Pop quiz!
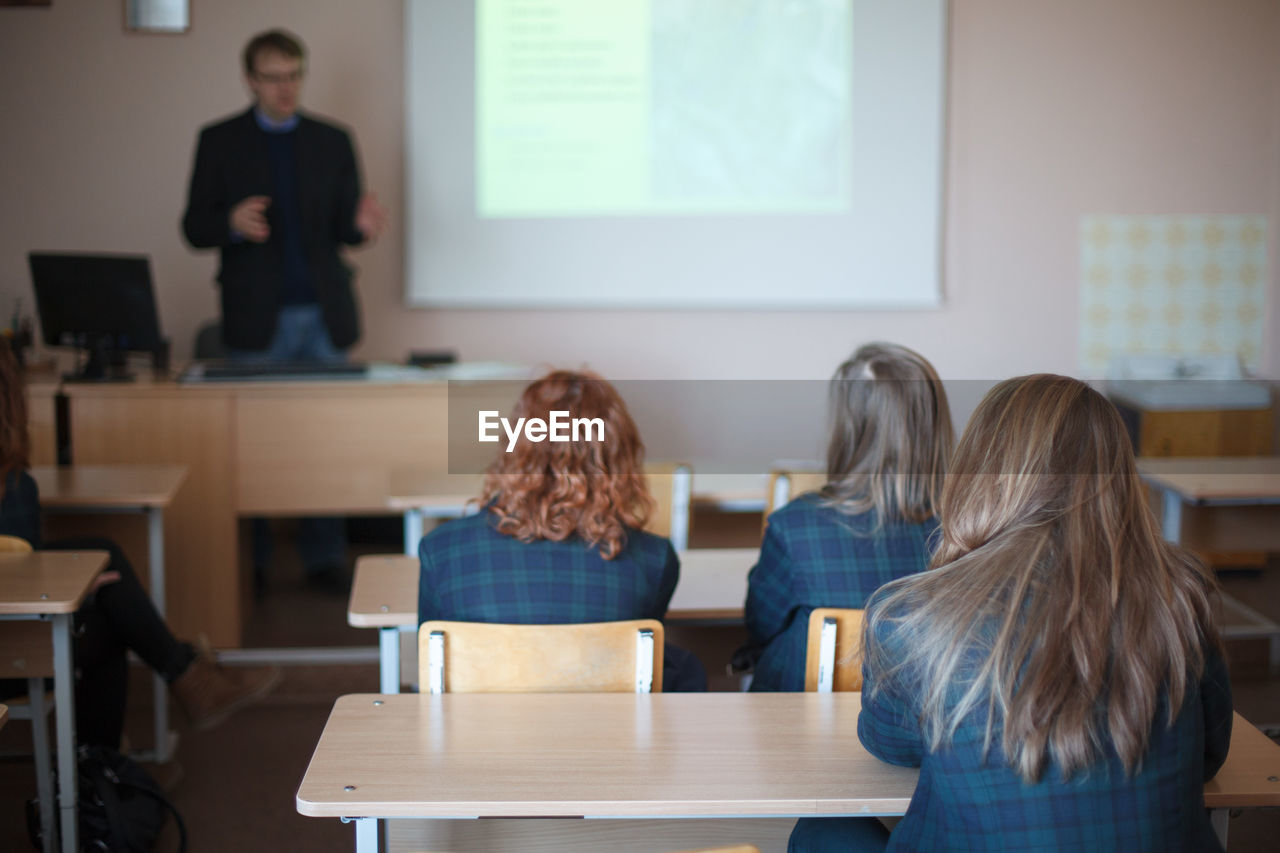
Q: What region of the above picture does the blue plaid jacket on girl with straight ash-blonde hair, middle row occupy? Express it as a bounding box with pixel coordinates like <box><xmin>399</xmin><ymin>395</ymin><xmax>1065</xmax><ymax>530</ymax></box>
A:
<box><xmin>745</xmin><ymin>494</ymin><xmax>938</xmax><ymax>690</ymax></box>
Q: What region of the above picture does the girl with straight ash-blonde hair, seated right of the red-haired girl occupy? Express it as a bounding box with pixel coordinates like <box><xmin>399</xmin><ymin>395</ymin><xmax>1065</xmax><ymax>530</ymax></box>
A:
<box><xmin>736</xmin><ymin>343</ymin><xmax>955</xmax><ymax>690</ymax></box>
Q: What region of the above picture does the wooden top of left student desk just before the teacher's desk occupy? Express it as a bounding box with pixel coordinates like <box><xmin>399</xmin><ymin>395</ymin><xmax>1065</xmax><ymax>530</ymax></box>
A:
<box><xmin>31</xmin><ymin>465</ymin><xmax>187</xmax><ymax>508</ymax></box>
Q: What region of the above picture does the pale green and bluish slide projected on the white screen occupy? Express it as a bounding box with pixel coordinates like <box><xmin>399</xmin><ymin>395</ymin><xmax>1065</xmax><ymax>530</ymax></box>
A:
<box><xmin>475</xmin><ymin>0</ymin><xmax>854</xmax><ymax>218</ymax></box>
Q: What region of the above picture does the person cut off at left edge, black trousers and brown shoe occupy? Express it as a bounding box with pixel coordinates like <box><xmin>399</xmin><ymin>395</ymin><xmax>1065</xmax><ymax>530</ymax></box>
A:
<box><xmin>0</xmin><ymin>342</ymin><xmax>280</xmax><ymax>749</ymax></box>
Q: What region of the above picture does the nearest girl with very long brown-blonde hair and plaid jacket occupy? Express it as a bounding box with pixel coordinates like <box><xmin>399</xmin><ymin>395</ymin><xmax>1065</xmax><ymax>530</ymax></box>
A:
<box><xmin>790</xmin><ymin>375</ymin><xmax>1231</xmax><ymax>852</ymax></box>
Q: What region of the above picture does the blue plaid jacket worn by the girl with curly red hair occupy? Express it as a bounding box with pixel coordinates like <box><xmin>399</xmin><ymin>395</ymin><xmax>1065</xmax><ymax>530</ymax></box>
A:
<box><xmin>417</xmin><ymin>512</ymin><xmax>680</xmax><ymax>625</ymax></box>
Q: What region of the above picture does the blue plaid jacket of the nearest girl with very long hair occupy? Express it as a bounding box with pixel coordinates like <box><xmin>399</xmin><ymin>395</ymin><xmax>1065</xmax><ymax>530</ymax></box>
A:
<box><xmin>858</xmin><ymin>594</ymin><xmax>1231</xmax><ymax>853</ymax></box>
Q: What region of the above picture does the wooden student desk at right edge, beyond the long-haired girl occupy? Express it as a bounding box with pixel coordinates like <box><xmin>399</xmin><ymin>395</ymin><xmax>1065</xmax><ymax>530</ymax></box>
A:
<box><xmin>1138</xmin><ymin>456</ymin><xmax>1280</xmax><ymax>672</ymax></box>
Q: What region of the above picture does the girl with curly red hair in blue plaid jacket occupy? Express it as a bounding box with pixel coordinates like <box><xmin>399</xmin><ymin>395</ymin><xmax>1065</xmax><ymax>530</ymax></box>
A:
<box><xmin>417</xmin><ymin>370</ymin><xmax>707</xmax><ymax>692</ymax></box>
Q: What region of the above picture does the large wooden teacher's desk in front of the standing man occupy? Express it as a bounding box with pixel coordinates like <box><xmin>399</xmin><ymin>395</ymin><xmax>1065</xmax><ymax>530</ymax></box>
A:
<box><xmin>29</xmin><ymin>365</ymin><xmax>524</xmax><ymax>648</ymax></box>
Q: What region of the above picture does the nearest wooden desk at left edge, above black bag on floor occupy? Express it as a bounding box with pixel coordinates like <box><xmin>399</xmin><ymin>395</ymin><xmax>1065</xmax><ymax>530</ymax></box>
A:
<box><xmin>0</xmin><ymin>551</ymin><xmax>108</xmax><ymax>853</ymax></box>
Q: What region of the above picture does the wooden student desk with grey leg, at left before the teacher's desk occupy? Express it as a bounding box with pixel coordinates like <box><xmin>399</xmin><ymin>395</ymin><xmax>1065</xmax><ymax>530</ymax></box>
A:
<box><xmin>31</xmin><ymin>465</ymin><xmax>187</xmax><ymax>765</ymax></box>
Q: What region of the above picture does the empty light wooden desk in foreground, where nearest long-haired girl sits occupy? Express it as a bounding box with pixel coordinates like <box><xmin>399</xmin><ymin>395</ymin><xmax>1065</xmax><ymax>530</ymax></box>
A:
<box><xmin>297</xmin><ymin>693</ymin><xmax>1280</xmax><ymax>853</ymax></box>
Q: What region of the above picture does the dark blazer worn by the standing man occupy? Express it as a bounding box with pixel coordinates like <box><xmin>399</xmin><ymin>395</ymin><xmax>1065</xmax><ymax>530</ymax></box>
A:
<box><xmin>182</xmin><ymin>109</ymin><xmax>364</xmax><ymax>350</ymax></box>
